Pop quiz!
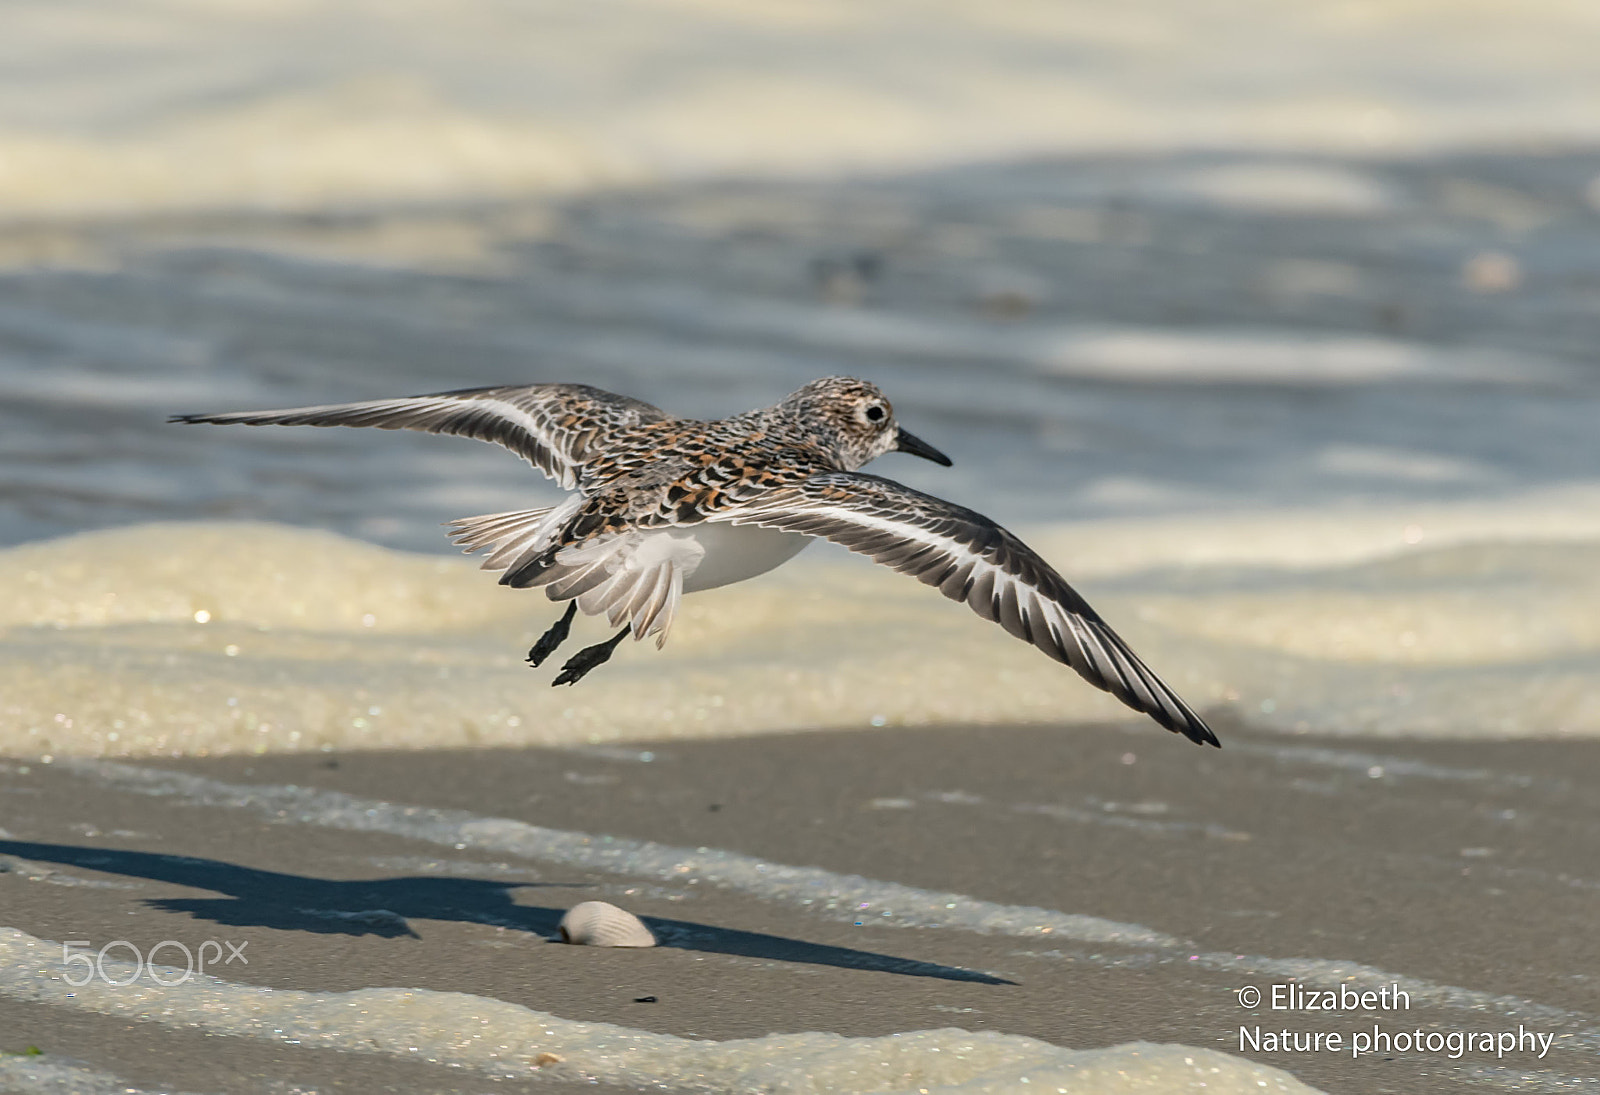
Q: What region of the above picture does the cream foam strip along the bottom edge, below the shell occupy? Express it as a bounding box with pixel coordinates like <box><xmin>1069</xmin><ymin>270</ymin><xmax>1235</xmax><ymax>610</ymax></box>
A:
<box><xmin>0</xmin><ymin>929</ymin><xmax>1312</xmax><ymax>1095</ymax></box>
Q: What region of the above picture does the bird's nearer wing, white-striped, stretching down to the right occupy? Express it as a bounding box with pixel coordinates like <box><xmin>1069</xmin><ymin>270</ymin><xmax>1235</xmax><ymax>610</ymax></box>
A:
<box><xmin>717</xmin><ymin>472</ymin><xmax>1219</xmax><ymax>744</ymax></box>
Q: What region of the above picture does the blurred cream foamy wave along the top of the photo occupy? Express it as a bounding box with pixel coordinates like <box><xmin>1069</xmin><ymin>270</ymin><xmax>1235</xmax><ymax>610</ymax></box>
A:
<box><xmin>9</xmin><ymin>0</ymin><xmax>1600</xmax><ymax>219</ymax></box>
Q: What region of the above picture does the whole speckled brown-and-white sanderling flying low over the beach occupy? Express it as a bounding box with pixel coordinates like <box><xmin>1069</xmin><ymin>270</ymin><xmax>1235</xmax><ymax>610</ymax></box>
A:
<box><xmin>171</xmin><ymin>376</ymin><xmax>1219</xmax><ymax>744</ymax></box>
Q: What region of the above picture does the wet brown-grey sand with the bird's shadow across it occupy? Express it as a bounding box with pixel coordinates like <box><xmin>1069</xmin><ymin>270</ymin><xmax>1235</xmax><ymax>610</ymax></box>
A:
<box><xmin>0</xmin><ymin>725</ymin><xmax>1600</xmax><ymax>1092</ymax></box>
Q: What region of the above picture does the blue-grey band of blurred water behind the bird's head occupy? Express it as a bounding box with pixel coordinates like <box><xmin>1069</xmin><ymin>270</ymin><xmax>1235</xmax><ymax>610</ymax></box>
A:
<box><xmin>0</xmin><ymin>154</ymin><xmax>1600</xmax><ymax>551</ymax></box>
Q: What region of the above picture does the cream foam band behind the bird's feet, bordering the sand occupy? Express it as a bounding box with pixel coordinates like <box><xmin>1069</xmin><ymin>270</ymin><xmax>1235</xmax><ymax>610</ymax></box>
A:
<box><xmin>0</xmin><ymin>488</ymin><xmax>1600</xmax><ymax>756</ymax></box>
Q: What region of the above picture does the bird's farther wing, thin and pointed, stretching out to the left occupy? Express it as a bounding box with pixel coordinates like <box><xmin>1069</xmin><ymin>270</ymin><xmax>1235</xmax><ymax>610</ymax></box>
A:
<box><xmin>168</xmin><ymin>384</ymin><xmax>667</xmax><ymax>490</ymax></box>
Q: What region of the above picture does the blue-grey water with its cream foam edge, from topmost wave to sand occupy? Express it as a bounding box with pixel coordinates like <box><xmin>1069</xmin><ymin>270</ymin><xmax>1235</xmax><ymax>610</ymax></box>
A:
<box><xmin>9</xmin><ymin>154</ymin><xmax>1600</xmax><ymax>756</ymax></box>
